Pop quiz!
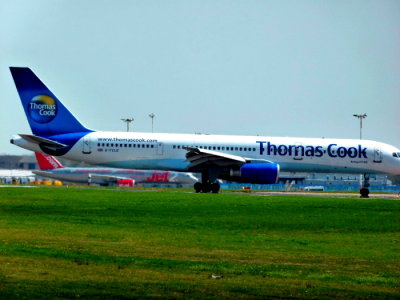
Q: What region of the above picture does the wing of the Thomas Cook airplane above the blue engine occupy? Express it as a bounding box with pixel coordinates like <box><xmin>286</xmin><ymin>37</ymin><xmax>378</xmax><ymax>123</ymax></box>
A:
<box><xmin>184</xmin><ymin>147</ymin><xmax>270</xmax><ymax>170</ymax></box>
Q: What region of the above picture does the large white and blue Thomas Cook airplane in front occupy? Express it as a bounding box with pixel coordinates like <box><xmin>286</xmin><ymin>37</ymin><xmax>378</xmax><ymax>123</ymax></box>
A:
<box><xmin>10</xmin><ymin>67</ymin><xmax>400</xmax><ymax>197</ymax></box>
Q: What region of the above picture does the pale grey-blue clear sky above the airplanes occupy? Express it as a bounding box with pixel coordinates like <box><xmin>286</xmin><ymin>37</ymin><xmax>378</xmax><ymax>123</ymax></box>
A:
<box><xmin>0</xmin><ymin>0</ymin><xmax>400</xmax><ymax>154</ymax></box>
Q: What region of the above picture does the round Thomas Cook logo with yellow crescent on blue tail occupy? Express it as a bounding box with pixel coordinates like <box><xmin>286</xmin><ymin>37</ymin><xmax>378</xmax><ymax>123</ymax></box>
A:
<box><xmin>28</xmin><ymin>95</ymin><xmax>57</xmax><ymax>123</ymax></box>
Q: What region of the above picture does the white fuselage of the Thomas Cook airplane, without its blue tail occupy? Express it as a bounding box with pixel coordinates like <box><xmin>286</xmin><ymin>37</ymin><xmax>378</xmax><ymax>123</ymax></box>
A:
<box><xmin>14</xmin><ymin>131</ymin><xmax>400</xmax><ymax>175</ymax></box>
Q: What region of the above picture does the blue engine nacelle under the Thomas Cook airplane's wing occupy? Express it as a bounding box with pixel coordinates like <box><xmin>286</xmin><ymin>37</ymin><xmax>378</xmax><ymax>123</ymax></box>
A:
<box><xmin>230</xmin><ymin>163</ymin><xmax>279</xmax><ymax>184</ymax></box>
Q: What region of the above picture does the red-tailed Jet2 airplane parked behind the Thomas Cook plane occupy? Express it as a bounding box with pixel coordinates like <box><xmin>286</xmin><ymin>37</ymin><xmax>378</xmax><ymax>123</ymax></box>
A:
<box><xmin>32</xmin><ymin>152</ymin><xmax>198</xmax><ymax>186</ymax></box>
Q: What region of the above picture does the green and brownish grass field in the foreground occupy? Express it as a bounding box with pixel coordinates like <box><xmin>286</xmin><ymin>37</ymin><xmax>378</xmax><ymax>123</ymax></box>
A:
<box><xmin>0</xmin><ymin>187</ymin><xmax>400</xmax><ymax>299</ymax></box>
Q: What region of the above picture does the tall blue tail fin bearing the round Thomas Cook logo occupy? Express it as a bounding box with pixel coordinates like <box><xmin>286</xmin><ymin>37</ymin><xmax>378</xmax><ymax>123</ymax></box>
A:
<box><xmin>10</xmin><ymin>67</ymin><xmax>92</xmax><ymax>135</ymax></box>
